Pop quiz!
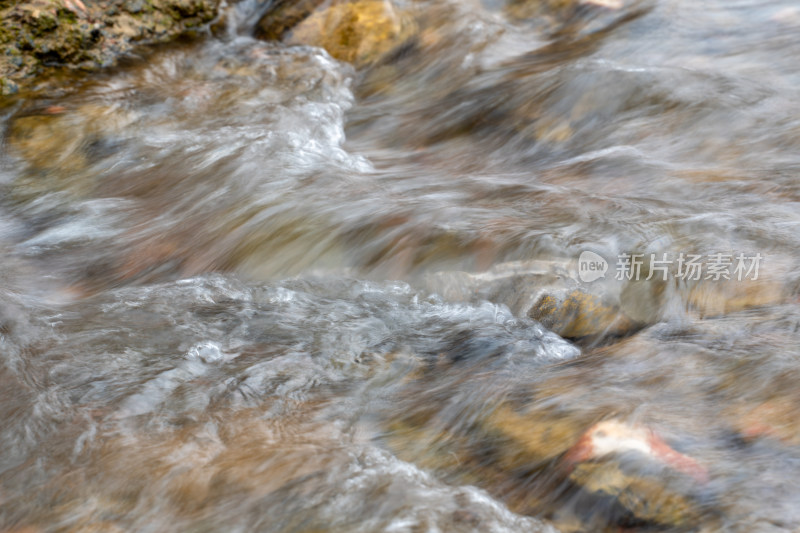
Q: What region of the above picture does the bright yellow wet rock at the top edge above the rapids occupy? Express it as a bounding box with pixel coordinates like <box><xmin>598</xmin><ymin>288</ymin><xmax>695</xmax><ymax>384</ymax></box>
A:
<box><xmin>287</xmin><ymin>0</ymin><xmax>416</xmax><ymax>67</ymax></box>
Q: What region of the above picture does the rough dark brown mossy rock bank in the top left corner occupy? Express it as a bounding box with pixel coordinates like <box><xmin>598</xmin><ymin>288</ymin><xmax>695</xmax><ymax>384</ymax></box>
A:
<box><xmin>0</xmin><ymin>0</ymin><xmax>219</xmax><ymax>95</ymax></box>
